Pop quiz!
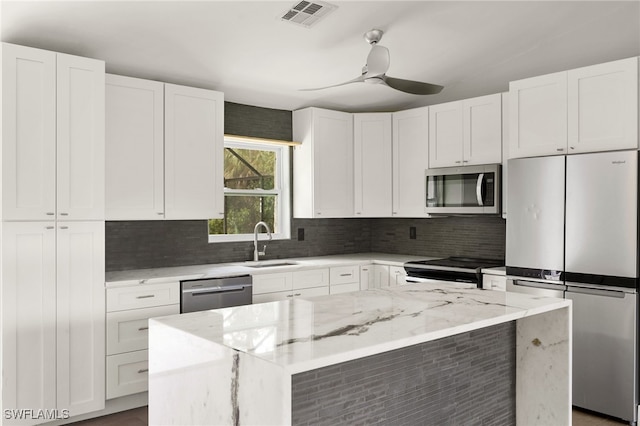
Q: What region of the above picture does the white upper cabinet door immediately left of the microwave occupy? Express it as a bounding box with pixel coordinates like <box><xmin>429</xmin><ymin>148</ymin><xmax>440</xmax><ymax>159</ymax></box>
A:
<box><xmin>391</xmin><ymin>107</ymin><xmax>429</xmax><ymax>217</ymax></box>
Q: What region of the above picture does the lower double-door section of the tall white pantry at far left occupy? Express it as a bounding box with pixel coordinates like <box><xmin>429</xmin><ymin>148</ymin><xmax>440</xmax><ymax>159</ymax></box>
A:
<box><xmin>1</xmin><ymin>221</ymin><xmax>105</xmax><ymax>424</ymax></box>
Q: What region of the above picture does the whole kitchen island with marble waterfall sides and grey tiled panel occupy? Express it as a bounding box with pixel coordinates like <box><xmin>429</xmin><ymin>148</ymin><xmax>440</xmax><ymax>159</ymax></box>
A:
<box><xmin>149</xmin><ymin>284</ymin><xmax>571</xmax><ymax>425</ymax></box>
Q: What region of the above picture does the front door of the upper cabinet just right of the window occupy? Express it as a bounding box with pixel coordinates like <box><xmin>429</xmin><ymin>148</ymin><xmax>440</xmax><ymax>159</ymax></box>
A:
<box><xmin>313</xmin><ymin>110</ymin><xmax>353</xmax><ymax>217</ymax></box>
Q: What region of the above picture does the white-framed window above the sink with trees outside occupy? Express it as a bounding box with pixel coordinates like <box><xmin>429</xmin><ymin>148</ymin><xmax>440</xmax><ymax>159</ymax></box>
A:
<box><xmin>209</xmin><ymin>140</ymin><xmax>291</xmax><ymax>242</ymax></box>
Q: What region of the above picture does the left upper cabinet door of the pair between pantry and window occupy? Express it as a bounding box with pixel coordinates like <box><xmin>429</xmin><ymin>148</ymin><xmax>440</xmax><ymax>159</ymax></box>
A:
<box><xmin>105</xmin><ymin>74</ymin><xmax>164</xmax><ymax>220</ymax></box>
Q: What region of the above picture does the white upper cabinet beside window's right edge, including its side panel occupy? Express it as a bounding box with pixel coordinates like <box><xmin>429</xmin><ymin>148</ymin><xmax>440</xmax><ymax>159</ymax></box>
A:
<box><xmin>293</xmin><ymin>108</ymin><xmax>354</xmax><ymax>218</ymax></box>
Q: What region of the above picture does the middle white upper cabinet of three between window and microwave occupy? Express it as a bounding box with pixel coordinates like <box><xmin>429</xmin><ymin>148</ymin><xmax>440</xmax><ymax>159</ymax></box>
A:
<box><xmin>353</xmin><ymin>113</ymin><xmax>392</xmax><ymax>217</ymax></box>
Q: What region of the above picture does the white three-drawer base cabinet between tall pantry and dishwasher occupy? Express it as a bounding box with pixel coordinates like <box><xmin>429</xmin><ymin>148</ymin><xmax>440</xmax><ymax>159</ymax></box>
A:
<box><xmin>106</xmin><ymin>281</ymin><xmax>180</xmax><ymax>399</ymax></box>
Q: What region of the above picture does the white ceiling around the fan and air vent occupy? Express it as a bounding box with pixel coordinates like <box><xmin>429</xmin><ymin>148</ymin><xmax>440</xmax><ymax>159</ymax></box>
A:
<box><xmin>0</xmin><ymin>0</ymin><xmax>640</xmax><ymax>111</ymax></box>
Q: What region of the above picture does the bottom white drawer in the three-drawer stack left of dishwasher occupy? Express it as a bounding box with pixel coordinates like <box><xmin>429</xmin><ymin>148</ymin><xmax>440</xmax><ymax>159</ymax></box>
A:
<box><xmin>107</xmin><ymin>351</ymin><xmax>149</xmax><ymax>399</ymax></box>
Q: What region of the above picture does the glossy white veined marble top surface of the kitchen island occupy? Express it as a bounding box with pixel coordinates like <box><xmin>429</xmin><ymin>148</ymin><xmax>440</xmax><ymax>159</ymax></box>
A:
<box><xmin>150</xmin><ymin>284</ymin><xmax>571</xmax><ymax>374</ymax></box>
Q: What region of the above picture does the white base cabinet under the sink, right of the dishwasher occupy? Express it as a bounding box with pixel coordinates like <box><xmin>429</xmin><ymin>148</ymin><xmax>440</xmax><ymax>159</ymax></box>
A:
<box><xmin>252</xmin><ymin>268</ymin><xmax>329</xmax><ymax>303</ymax></box>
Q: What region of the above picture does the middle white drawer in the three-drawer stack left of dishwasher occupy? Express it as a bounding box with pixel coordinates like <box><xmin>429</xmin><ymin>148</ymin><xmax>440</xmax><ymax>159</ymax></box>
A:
<box><xmin>107</xmin><ymin>304</ymin><xmax>180</xmax><ymax>355</ymax></box>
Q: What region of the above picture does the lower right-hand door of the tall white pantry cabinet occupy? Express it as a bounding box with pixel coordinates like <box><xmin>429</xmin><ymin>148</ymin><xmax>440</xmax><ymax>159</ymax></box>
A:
<box><xmin>56</xmin><ymin>222</ymin><xmax>106</xmax><ymax>416</ymax></box>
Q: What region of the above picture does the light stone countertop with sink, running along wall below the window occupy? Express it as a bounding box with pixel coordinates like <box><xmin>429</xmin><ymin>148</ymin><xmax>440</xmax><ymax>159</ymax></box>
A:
<box><xmin>105</xmin><ymin>253</ymin><xmax>437</xmax><ymax>287</ymax></box>
